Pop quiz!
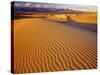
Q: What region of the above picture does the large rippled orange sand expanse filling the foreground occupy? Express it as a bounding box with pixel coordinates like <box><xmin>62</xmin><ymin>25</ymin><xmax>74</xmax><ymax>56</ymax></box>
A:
<box><xmin>14</xmin><ymin>18</ymin><xmax>97</xmax><ymax>73</ymax></box>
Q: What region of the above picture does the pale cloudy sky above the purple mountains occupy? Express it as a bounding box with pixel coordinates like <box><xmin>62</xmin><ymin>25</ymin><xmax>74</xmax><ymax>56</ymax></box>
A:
<box><xmin>14</xmin><ymin>1</ymin><xmax>97</xmax><ymax>12</ymax></box>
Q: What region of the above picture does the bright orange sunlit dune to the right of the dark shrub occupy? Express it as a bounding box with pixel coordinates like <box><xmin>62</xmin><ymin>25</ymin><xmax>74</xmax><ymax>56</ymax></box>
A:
<box><xmin>71</xmin><ymin>13</ymin><xmax>97</xmax><ymax>24</ymax></box>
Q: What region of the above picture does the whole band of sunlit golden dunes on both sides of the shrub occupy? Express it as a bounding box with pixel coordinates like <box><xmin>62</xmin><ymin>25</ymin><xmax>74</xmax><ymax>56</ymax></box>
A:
<box><xmin>47</xmin><ymin>13</ymin><xmax>97</xmax><ymax>24</ymax></box>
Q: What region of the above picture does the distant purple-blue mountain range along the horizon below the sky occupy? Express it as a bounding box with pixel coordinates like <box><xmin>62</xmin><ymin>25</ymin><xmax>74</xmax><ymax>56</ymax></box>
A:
<box><xmin>14</xmin><ymin>7</ymin><xmax>92</xmax><ymax>14</ymax></box>
